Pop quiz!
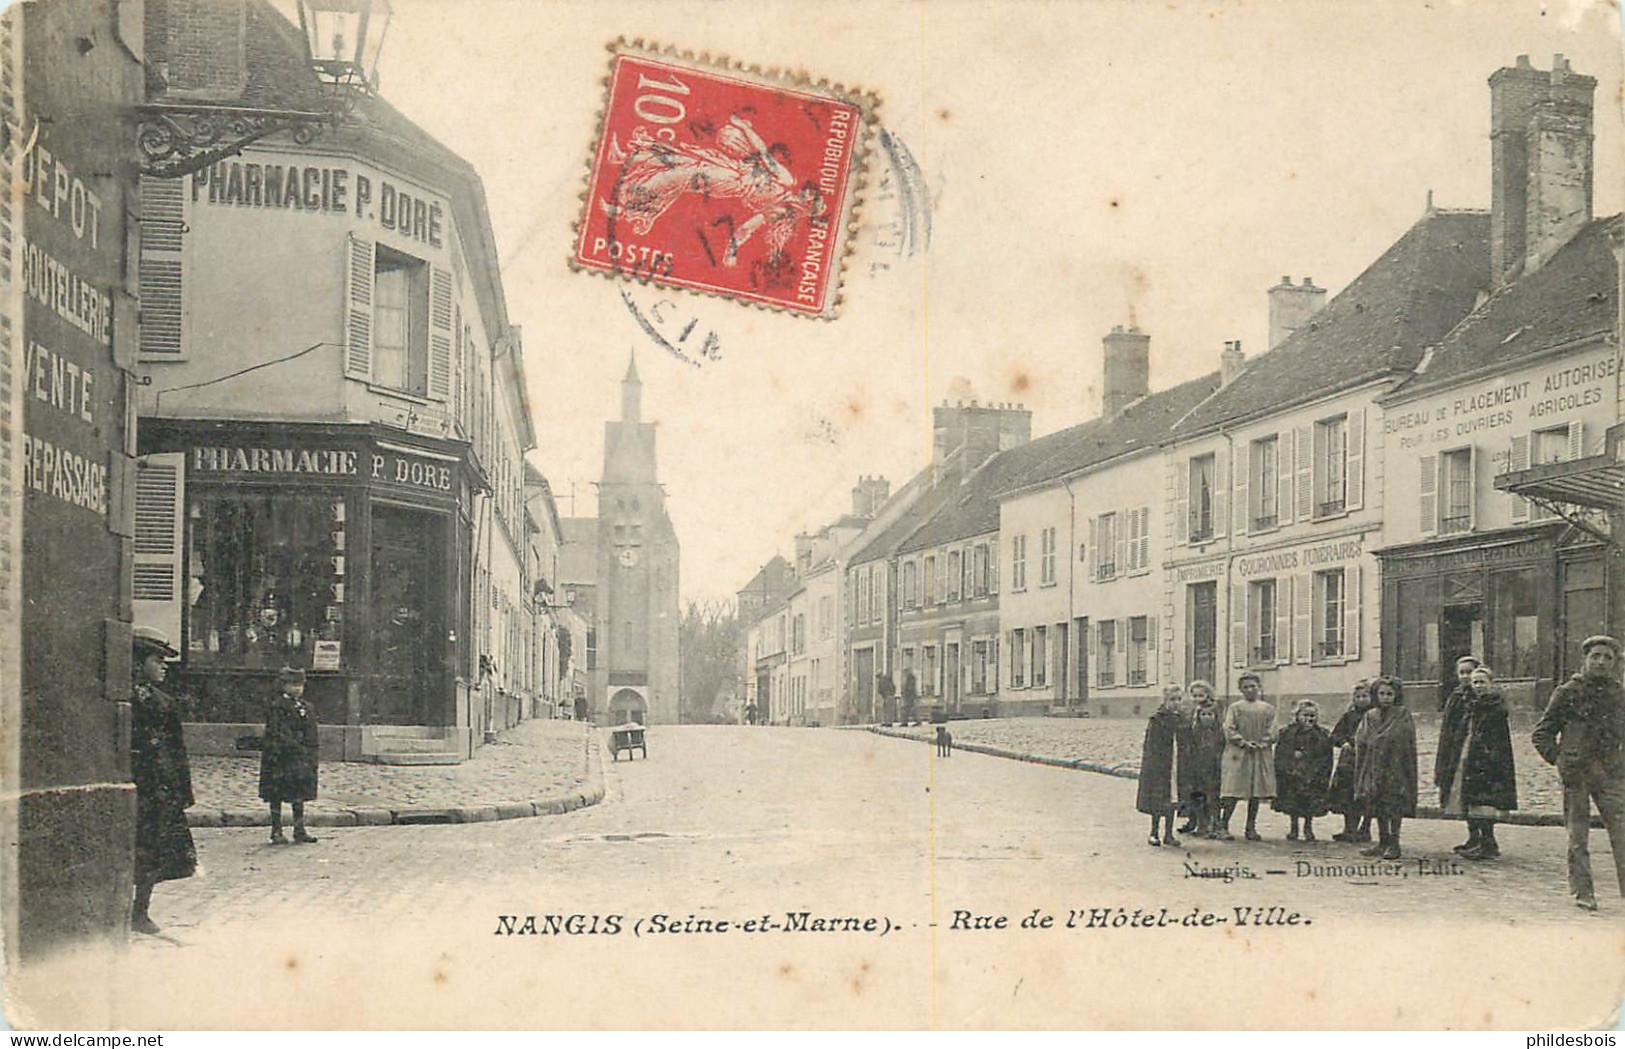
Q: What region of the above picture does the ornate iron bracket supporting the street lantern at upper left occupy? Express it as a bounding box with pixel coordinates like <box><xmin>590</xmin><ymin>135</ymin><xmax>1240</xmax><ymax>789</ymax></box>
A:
<box><xmin>135</xmin><ymin>104</ymin><xmax>340</xmax><ymax>179</ymax></box>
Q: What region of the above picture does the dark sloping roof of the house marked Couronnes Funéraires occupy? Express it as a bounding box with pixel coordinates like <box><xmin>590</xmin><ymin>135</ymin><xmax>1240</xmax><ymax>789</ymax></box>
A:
<box><xmin>1173</xmin><ymin>209</ymin><xmax>1490</xmax><ymax>438</ymax></box>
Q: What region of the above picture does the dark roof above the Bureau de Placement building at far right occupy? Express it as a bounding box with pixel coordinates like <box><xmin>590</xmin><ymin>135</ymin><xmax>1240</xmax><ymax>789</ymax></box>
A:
<box><xmin>1399</xmin><ymin>214</ymin><xmax>1625</xmax><ymax>396</ymax></box>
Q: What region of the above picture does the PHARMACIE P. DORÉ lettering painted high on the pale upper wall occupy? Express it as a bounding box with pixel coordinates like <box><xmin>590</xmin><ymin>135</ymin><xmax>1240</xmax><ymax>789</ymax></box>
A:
<box><xmin>192</xmin><ymin>158</ymin><xmax>445</xmax><ymax>248</ymax></box>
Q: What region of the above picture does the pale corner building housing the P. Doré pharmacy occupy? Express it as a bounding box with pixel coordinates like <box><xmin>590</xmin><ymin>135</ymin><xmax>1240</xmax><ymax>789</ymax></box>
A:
<box><xmin>133</xmin><ymin>0</ymin><xmax>535</xmax><ymax>760</ymax></box>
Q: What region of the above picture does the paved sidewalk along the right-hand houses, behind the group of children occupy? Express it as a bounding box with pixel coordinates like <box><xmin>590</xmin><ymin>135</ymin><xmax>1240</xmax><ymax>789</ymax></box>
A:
<box><xmin>869</xmin><ymin>718</ymin><xmax>1563</xmax><ymax>825</ymax></box>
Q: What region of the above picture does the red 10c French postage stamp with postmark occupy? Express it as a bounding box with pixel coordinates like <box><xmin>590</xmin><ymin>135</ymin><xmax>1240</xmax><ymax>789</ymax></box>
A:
<box><xmin>572</xmin><ymin>50</ymin><xmax>869</xmax><ymax>317</ymax></box>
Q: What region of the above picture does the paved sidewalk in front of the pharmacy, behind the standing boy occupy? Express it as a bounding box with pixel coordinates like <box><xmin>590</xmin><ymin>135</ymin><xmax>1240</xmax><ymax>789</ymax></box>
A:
<box><xmin>187</xmin><ymin>721</ymin><xmax>605</xmax><ymax>827</ymax></box>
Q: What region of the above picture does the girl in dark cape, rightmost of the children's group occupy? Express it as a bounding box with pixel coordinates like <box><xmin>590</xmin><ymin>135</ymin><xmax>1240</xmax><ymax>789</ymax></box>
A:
<box><xmin>1433</xmin><ymin>664</ymin><xmax>1518</xmax><ymax>859</ymax></box>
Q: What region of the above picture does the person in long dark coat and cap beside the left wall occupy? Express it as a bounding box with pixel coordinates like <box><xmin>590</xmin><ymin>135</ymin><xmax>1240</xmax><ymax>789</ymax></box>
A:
<box><xmin>130</xmin><ymin>627</ymin><xmax>198</xmax><ymax>935</ymax></box>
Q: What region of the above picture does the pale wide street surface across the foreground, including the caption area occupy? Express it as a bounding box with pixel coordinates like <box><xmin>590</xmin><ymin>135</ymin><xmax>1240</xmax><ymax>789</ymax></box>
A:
<box><xmin>15</xmin><ymin>727</ymin><xmax>1625</xmax><ymax>1028</ymax></box>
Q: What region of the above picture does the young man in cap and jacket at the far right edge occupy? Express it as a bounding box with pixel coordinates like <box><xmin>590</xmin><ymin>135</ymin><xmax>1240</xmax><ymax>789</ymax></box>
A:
<box><xmin>1534</xmin><ymin>635</ymin><xmax>1625</xmax><ymax>911</ymax></box>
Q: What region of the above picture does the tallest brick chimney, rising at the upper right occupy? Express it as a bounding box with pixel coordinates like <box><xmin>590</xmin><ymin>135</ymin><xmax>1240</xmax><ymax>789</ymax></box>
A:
<box><xmin>1490</xmin><ymin>55</ymin><xmax>1597</xmax><ymax>287</ymax></box>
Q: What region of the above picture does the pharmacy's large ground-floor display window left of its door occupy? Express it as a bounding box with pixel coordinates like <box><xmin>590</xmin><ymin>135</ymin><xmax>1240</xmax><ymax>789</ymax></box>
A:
<box><xmin>187</xmin><ymin>492</ymin><xmax>346</xmax><ymax>667</ymax></box>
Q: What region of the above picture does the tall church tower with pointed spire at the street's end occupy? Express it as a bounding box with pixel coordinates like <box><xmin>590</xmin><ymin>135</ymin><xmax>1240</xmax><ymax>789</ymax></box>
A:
<box><xmin>593</xmin><ymin>359</ymin><xmax>679</xmax><ymax>724</ymax></box>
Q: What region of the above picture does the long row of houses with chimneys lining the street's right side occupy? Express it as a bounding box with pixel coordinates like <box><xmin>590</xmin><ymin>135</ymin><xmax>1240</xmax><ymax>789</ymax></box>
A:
<box><xmin>739</xmin><ymin>55</ymin><xmax>1625</xmax><ymax>724</ymax></box>
